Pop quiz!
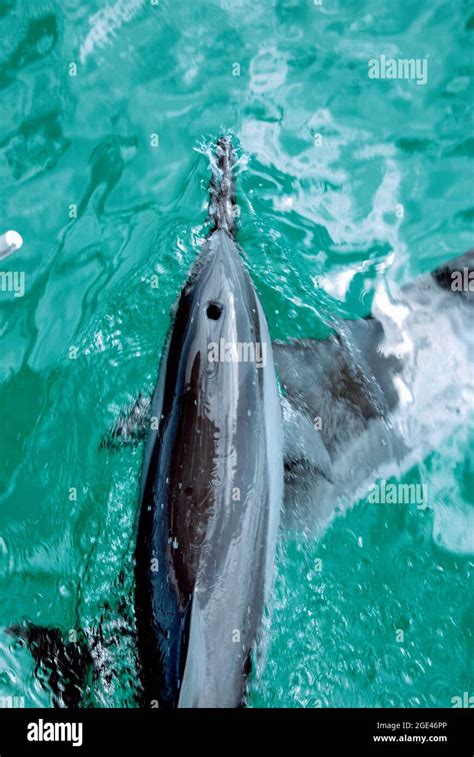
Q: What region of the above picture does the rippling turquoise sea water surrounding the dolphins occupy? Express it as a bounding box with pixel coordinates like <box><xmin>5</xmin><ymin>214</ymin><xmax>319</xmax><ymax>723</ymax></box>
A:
<box><xmin>0</xmin><ymin>0</ymin><xmax>474</xmax><ymax>707</ymax></box>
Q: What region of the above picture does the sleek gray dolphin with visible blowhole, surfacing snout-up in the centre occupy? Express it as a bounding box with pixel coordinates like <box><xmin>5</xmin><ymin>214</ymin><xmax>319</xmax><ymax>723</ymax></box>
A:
<box><xmin>135</xmin><ymin>138</ymin><xmax>283</xmax><ymax>708</ymax></box>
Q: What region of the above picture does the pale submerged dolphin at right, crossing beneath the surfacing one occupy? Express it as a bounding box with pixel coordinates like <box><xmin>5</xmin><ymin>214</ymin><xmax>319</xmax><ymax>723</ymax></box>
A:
<box><xmin>273</xmin><ymin>250</ymin><xmax>474</xmax><ymax>535</ymax></box>
